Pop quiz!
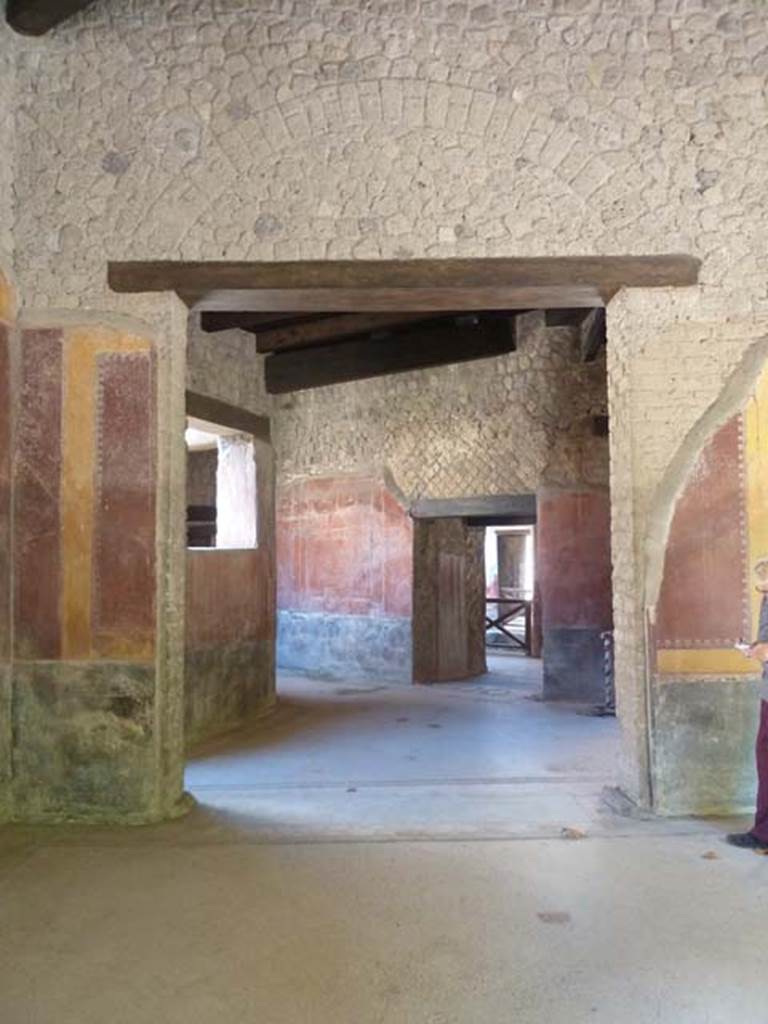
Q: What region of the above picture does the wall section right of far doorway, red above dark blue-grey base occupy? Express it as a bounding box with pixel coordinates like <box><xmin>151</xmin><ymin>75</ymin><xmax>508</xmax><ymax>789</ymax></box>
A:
<box><xmin>537</xmin><ymin>490</ymin><xmax>612</xmax><ymax>703</ymax></box>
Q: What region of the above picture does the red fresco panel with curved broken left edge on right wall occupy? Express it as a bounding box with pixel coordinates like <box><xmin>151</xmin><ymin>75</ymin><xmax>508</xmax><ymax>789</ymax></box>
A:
<box><xmin>656</xmin><ymin>416</ymin><xmax>750</xmax><ymax>647</ymax></box>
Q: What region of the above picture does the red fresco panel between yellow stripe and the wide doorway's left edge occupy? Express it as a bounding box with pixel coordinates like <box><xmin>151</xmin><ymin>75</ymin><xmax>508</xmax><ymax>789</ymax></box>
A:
<box><xmin>93</xmin><ymin>352</ymin><xmax>155</xmax><ymax>640</ymax></box>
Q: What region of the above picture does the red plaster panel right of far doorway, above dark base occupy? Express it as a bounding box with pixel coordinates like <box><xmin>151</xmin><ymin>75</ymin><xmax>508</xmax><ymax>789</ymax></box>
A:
<box><xmin>537</xmin><ymin>492</ymin><xmax>612</xmax><ymax>629</ymax></box>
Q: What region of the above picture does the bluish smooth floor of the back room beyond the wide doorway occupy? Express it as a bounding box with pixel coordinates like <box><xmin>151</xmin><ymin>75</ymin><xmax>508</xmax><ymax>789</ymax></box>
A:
<box><xmin>186</xmin><ymin>654</ymin><xmax>618</xmax><ymax>839</ymax></box>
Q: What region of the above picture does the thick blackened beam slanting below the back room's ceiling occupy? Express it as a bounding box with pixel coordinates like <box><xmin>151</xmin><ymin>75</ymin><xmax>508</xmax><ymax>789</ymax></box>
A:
<box><xmin>264</xmin><ymin>316</ymin><xmax>516</xmax><ymax>394</ymax></box>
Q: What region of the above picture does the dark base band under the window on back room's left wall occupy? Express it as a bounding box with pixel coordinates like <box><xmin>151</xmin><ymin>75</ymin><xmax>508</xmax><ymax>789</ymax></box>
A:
<box><xmin>184</xmin><ymin>640</ymin><xmax>274</xmax><ymax>746</ymax></box>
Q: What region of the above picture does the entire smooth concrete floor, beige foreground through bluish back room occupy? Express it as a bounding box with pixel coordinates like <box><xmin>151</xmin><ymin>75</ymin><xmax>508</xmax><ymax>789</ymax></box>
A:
<box><xmin>0</xmin><ymin>663</ymin><xmax>768</xmax><ymax>1024</ymax></box>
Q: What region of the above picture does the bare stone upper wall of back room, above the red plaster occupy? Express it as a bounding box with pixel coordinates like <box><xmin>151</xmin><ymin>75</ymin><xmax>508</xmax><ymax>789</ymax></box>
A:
<box><xmin>275</xmin><ymin>313</ymin><xmax>608</xmax><ymax>505</ymax></box>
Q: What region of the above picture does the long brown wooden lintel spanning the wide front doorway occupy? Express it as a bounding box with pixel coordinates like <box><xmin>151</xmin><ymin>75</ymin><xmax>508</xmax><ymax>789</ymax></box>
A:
<box><xmin>109</xmin><ymin>255</ymin><xmax>699</xmax><ymax>312</ymax></box>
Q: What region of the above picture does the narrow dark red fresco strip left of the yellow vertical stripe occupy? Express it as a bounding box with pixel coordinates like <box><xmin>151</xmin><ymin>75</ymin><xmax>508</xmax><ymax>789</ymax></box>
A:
<box><xmin>13</xmin><ymin>330</ymin><xmax>62</xmax><ymax>659</ymax></box>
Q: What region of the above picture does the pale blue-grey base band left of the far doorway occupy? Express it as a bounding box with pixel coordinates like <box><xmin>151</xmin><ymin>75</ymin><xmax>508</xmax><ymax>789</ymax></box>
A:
<box><xmin>278</xmin><ymin>610</ymin><xmax>412</xmax><ymax>683</ymax></box>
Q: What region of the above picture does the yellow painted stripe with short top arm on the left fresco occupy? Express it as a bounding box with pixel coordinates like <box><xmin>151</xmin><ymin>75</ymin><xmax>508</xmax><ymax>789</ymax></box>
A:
<box><xmin>61</xmin><ymin>328</ymin><xmax>150</xmax><ymax>659</ymax></box>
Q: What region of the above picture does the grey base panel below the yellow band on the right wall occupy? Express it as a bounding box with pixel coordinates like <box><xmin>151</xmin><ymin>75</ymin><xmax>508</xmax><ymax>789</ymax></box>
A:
<box><xmin>653</xmin><ymin>678</ymin><xmax>760</xmax><ymax>815</ymax></box>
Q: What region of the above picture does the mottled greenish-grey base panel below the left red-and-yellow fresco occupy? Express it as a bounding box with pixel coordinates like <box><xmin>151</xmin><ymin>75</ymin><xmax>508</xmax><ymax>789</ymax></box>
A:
<box><xmin>13</xmin><ymin>662</ymin><xmax>156</xmax><ymax>821</ymax></box>
